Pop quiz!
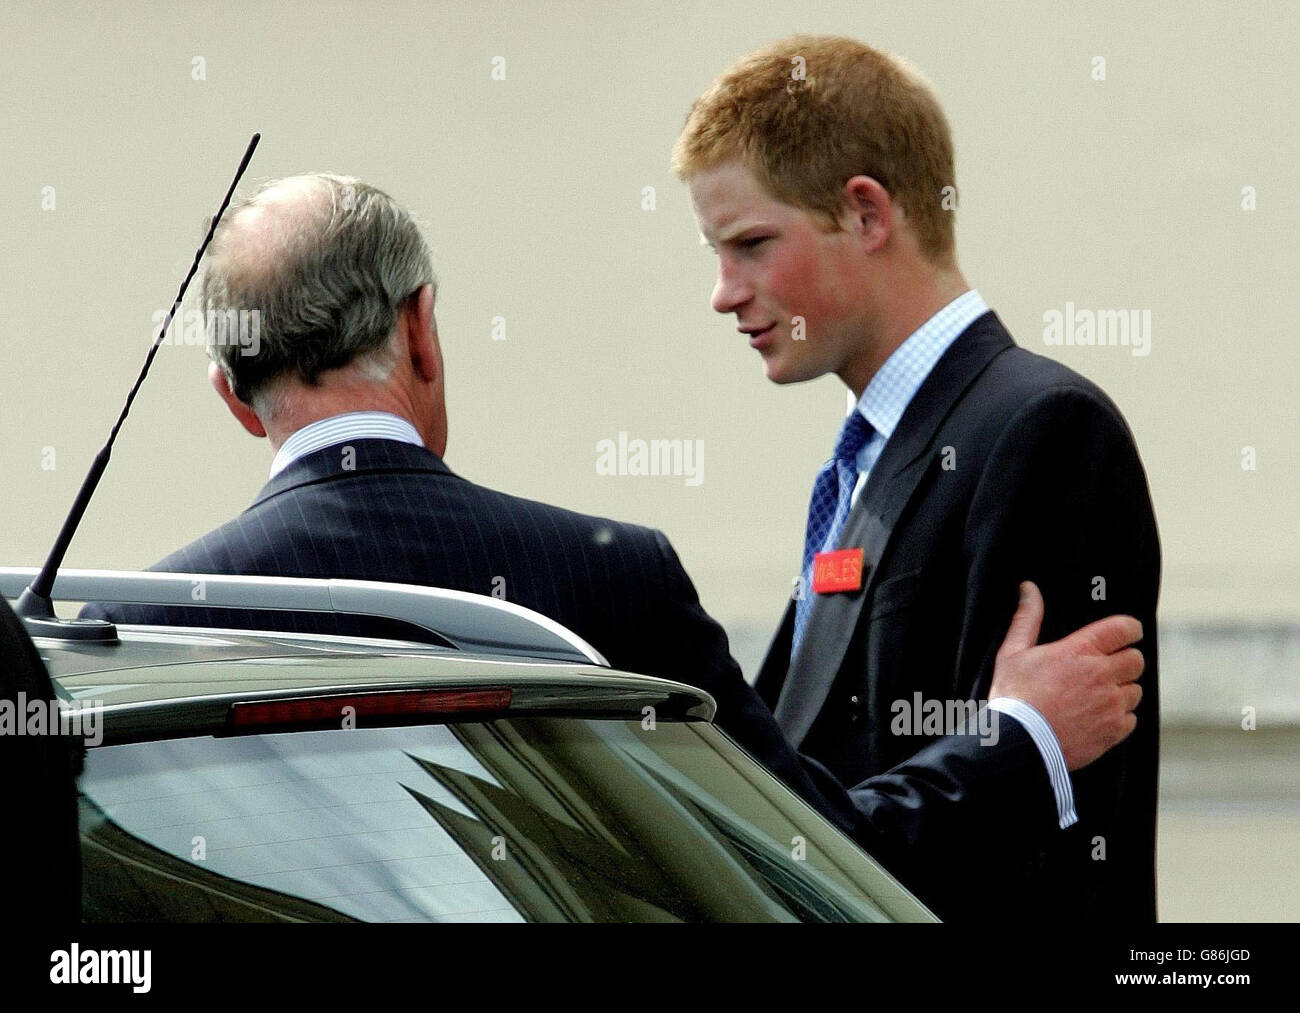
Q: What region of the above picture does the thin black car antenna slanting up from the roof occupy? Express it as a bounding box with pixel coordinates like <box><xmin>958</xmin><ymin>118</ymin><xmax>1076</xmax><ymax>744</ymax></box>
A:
<box><xmin>14</xmin><ymin>134</ymin><xmax>261</xmax><ymax>640</ymax></box>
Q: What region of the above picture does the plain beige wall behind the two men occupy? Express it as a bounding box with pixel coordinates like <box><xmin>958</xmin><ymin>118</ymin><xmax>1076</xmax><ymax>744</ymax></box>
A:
<box><xmin>0</xmin><ymin>0</ymin><xmax>1300</xmax><ymax>625</ymax></box>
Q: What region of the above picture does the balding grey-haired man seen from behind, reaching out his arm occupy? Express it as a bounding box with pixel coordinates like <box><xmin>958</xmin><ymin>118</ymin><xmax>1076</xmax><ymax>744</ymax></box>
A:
<box><xmin>86</xmin><ymin>174</ymin><xmax>1141</xmax><ymax>894</ymax></box>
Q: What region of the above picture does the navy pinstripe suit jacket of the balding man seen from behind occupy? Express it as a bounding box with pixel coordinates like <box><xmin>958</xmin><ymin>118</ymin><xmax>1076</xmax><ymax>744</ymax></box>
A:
<box><xmin>82</xmin><ymin>440</ymin><xmax>1057</xmax><ymax>899</ymax></box>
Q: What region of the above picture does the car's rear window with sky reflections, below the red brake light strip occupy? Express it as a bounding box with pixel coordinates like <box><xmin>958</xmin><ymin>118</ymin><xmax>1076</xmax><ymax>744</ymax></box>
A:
<box><xmin>81</xmin><ymin>717</ymin><xmax>928</xmax><ymax>922</ymax></box>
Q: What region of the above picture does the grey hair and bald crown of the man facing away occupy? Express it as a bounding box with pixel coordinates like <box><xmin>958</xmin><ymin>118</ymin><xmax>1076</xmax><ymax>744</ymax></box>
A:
<box><xmin>200</xmin><ymin>173</ymin><xmax>437</xmax><ymax>415</ymax></box>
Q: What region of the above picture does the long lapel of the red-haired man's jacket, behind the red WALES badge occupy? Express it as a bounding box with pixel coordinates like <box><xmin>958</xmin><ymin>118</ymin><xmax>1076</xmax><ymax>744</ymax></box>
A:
<box><xmin>764</xmin><ymin>312</ymin><xmax>1014</xmax><ymax>746</ymax></box>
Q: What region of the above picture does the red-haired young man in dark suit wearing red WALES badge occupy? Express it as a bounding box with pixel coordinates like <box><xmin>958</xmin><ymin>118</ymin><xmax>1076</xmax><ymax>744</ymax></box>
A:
<box><xmin>673</xmin><ymin>36</ymin><xmax>1160</xmax><ymax>921</ymax></box>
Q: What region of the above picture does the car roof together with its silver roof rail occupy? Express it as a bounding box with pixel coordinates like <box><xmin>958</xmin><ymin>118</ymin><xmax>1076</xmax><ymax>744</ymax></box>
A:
<box><xmin>0</xmin><ymin>567</ymin><xmax>715</xmax><ymax>741</ymax></box>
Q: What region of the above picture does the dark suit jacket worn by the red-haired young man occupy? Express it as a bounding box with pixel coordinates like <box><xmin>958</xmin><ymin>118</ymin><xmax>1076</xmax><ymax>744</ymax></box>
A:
<box><xmin>755</xmin><ymin>312</ymin><xmax>1160</xmax><ymax>922</ymax></box>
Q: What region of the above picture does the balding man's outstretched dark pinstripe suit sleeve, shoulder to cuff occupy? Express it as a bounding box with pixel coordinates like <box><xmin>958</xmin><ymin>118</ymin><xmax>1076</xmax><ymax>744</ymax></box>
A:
<box><xmin>641</xmin><ymin>532</ymin><xmax>1057</xmax><ymax>883</ymax></box>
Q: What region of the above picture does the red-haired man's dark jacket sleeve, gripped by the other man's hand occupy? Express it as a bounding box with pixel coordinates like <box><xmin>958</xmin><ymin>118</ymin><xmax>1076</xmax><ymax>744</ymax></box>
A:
<box><xmin>957</xmin><ymin>388</ymin><xmax>1160</xmax><ymax>921</ymax></box>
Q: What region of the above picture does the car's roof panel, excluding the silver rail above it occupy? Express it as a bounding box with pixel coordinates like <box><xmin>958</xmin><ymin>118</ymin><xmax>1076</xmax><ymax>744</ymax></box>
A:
<box><xmin>34</xmin><ymin>624</ymin><xmax>715</xmax><ymax>743</ymax></box>
